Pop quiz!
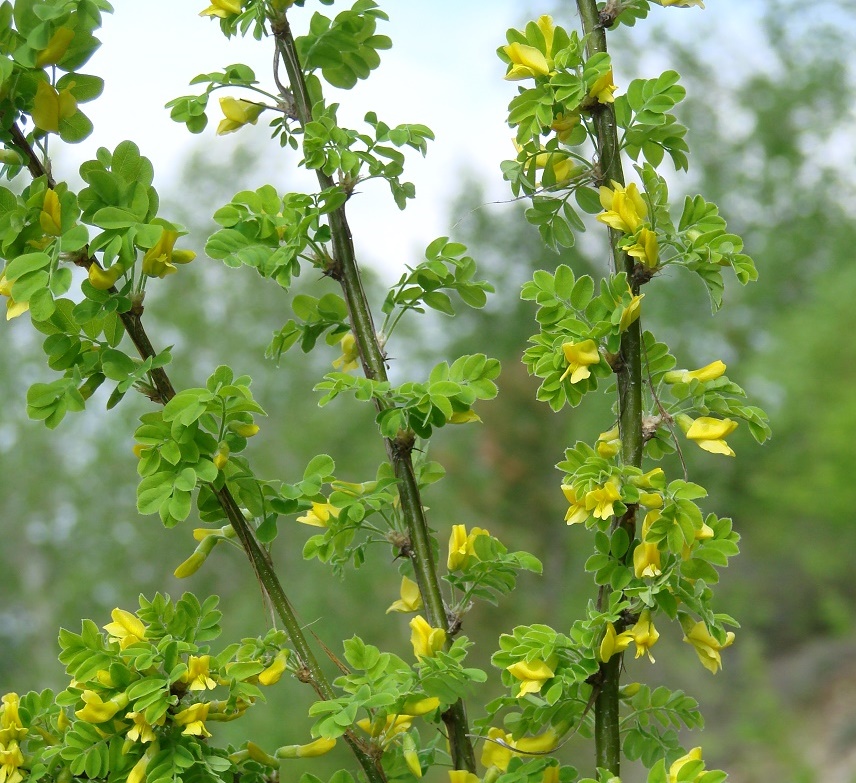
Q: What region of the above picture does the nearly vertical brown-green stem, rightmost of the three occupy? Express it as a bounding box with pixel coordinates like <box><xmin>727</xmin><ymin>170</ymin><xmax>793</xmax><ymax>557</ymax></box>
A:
<box><xmin>577</xmin><ymin>0</ymin><xmax>643</xmax><ymax>775</ymax></box>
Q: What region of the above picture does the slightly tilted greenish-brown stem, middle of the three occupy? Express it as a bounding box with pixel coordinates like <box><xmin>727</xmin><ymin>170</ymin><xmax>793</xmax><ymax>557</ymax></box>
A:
<box><xmin>272</xmin><ymin>13</ymin><xmax>476</xmax><ymax>772</ymax></box>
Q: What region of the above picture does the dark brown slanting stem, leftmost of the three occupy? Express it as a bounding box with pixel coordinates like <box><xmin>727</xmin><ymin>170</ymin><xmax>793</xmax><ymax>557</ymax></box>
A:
<box><xmin>3</xmin><ymin>118</ymin><xmax>386</xmax><ymax>783</ymax></box>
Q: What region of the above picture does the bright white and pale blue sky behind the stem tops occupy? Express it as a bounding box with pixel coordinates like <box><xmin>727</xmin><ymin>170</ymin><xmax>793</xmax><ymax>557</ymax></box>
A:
<box><xmin>55</xmin><ymin>0</ymin><xmax>755</xmax><ymax>282</ymax></box>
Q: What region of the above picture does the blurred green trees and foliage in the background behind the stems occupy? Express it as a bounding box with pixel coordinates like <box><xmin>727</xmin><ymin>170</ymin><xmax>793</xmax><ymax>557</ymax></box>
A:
<box><xmin>0</xmin><ymin>2</ymin><xmax>856</xmax><ymax>783</ymax></box>
